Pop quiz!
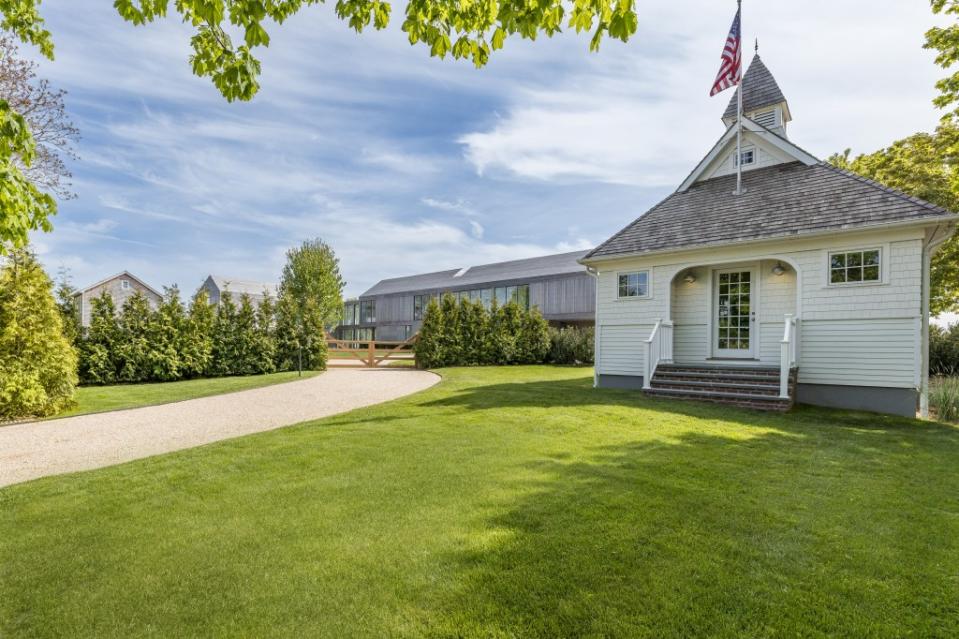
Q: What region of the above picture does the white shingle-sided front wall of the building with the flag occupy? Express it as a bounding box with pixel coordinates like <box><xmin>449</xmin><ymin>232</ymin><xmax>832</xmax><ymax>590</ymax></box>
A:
<box><xmin>596</xmin><ymin>229</ymin><xmax>922</xmax><ymax>388</ymax></box>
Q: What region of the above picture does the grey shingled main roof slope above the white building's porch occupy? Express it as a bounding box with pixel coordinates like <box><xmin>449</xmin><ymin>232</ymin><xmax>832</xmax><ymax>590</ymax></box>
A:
<box><xmin>583</xmin><ymin>162</ymin><xmax>953</xmax><ymax>260</ymax></box>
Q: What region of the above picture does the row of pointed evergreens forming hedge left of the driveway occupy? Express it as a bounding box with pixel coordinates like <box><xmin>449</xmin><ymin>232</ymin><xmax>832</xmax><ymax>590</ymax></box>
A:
<box><xmin>77</xmin><ymin>288</ymin><xmax>326</xmax><ymax>384</ymax></box>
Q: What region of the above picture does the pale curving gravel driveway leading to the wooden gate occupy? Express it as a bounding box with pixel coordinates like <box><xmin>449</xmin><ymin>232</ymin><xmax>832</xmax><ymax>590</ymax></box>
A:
<box><xmin>0</xmin><ymin>368</ymin><xmax>440</xmax><ymax>486</ymax></box>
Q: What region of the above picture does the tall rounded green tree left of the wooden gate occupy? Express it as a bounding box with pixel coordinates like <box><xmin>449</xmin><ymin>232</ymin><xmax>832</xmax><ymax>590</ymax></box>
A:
<box><xmin>280</xmin><ymin>239</ymin><xmax>344</xmax><ymax>370</ymax></box>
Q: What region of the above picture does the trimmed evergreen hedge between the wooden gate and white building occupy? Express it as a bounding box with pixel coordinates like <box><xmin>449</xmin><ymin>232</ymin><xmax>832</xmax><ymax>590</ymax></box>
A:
<box><xmin>414</xmin><ymin>293</ymin><xmax>551</xmax><ymax>368</ymax></box>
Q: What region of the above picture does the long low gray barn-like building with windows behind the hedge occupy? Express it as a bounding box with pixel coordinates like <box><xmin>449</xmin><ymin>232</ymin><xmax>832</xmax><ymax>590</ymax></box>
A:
<box><xmin>336</xmin><ymin>251</ymin><xmax>596</xmax><ymax>341</ymax></box>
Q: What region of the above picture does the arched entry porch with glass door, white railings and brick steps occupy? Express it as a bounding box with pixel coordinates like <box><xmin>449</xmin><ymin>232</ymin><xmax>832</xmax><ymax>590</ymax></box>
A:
<box><xmin>643</xmin><ymin>259</ymin><xmax>800</xmax><ymax>410</ymax></box>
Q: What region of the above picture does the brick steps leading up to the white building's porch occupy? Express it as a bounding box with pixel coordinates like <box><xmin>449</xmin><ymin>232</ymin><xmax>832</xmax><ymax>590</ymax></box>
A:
<box><xmin>644</xmin><ymin>364</ymin><xmax>796</xmax><ymax>411</ymax></box>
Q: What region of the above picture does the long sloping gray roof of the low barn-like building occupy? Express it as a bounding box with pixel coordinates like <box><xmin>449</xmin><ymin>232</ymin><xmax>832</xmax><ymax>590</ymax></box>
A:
<box><xmin>360</xmin><ymin>251</ymin><xmax>589</xmax><ymax>297</ymax></box>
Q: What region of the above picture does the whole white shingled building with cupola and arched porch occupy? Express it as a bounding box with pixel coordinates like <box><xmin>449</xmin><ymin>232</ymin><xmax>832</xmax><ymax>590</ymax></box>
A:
<box><xmin>581</xmin><ymin>55</ymin><xmax>957</xmax><ymax>415</ymax></box>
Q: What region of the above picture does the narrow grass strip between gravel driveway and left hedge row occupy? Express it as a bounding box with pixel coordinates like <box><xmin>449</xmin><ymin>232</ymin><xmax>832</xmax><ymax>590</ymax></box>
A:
<box><xmin>57</xmin><ymin>371</ymin><xmax>317</xmax><ymax>417</ymax></box>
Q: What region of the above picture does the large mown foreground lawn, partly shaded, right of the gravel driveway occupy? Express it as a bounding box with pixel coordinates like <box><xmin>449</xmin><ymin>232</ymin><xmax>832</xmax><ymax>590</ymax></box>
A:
<box><xmin>0</xmin><ymin>367</ymin><xmax>959</xmax><ymax>637</ymax></box>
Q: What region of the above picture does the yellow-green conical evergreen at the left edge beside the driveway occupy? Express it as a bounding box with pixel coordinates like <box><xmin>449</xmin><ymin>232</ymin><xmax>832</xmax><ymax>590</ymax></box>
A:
<box><xmin>0</xmin><ymin>250</ymin><xmax>77</xmax><ymax>419</ymax></box>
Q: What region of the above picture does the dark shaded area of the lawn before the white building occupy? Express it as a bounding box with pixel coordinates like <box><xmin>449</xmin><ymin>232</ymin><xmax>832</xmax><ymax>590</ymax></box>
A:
<box><xmin>408</xmin><ymin>380</ymin><xmax>959</xmax><ymax>637</ymax></box>
